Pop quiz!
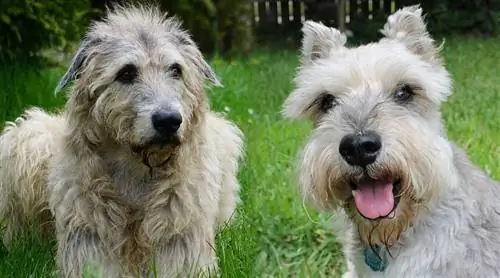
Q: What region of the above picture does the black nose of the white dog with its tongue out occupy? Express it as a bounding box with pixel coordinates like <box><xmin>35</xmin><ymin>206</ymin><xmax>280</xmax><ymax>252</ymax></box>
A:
<box><xmin>339</xmin><ymin>131</ymin><xmax>382</xmax><ymax>167</ymax></box>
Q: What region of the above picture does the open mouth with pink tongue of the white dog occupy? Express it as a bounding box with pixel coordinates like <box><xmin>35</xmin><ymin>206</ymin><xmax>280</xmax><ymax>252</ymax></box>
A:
<box><xmin>350</xmin><ymin>177</ymin><xmax>401</xmax><ymax>220</ymax></box>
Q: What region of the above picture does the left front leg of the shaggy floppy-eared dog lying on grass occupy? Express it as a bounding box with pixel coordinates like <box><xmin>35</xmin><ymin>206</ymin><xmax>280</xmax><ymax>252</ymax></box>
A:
<box><xmin>50</xmin><ymin>174</ymin><xmax>127</xmax><ymax>278</ymax></box>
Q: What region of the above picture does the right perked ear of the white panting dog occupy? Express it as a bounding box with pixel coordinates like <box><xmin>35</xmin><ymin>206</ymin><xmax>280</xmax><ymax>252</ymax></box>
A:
<box><xmin>381</xmin><ymin>5</ymin><xmax>440</xmax><ymax>61</ymax></box>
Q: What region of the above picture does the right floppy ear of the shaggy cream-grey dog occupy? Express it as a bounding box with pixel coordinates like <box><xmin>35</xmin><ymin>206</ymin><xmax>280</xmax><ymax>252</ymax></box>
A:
<box><xmin>176</xmin><ymin>32</ymin><xmax>223</xmax><ymax>87</ymax></box>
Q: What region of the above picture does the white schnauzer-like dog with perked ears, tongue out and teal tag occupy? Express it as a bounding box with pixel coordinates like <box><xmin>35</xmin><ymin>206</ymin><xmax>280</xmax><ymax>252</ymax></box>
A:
<box><xmin>283</xmin><ymin>5</ymin><xmax>500</xmax><ymax>278</ymax></box>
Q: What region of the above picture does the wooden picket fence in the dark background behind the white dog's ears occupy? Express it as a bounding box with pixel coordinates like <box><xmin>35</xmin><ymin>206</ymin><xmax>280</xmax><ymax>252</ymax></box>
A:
<box><xmin>252</xmin><ymin>0</ymin><xmax>419</xmax><ymax>40</ymax></box>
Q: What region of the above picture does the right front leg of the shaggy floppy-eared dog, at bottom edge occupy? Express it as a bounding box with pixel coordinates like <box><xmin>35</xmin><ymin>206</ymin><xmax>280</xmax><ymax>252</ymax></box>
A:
<box><xmin>152</xmin><ymin>227</ymin><xmax>218</xmax><ymax>278</ymax></box>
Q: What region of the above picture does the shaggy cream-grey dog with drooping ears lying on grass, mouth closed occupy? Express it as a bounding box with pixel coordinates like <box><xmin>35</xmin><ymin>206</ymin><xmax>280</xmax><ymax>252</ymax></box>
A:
<box><xmin>0</xmin><ymin>6</ymin><xmax>244</xmax><ymax>277</ymax></box>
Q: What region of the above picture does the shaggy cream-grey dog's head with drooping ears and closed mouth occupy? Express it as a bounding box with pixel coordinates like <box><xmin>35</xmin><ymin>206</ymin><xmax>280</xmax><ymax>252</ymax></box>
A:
<box><xmin>56</xmin><ymin>4</ymin><xmax>220</xmax><ymax>166</ymax></box>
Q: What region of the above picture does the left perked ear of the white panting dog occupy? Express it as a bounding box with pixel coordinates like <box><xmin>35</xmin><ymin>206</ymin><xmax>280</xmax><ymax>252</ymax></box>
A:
<box><xmin>301</xmin><ymin>20</ymin><xmax>347</xmax><ymax>64</ymax></box>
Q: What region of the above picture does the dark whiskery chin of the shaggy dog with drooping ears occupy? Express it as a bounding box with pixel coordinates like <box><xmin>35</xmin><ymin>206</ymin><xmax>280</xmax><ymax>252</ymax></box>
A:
<box><xmin>131</xmin><ymin>135</ymin><xmax>181</xmax><ymax>168</ymax></box>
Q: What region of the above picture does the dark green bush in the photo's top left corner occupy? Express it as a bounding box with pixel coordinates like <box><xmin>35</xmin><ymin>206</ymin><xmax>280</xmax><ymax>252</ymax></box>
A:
<box><xmin>0</xmin><ymin>0</ymin><xmax>90</xmax><ymax>59</ymax></box>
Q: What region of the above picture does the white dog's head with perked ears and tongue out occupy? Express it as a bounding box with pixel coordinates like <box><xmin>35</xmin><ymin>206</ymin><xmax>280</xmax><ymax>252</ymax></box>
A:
<box><xmin>284</xmin><ymin>6</ymin><xmax>454</xmax><ymax>243</ymax></box>
